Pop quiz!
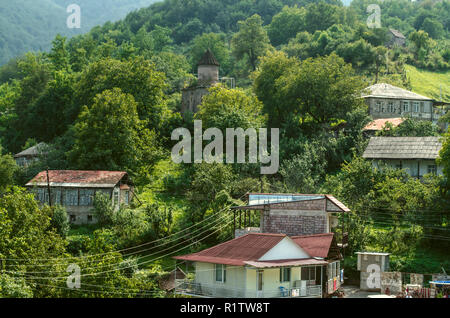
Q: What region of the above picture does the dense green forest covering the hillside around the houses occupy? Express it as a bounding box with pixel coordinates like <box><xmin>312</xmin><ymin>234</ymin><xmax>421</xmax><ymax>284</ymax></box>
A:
<box><xmin>0</xmin><ymin>0</ymin><xmax>450</xmax><ymax>297</ymax></box>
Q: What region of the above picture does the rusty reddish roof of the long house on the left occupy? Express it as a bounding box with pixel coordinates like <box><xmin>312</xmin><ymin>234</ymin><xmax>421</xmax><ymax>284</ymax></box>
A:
<box><xmin>27</xmin><ymin>170</ymin><xmax>127</xmax><ymax>186</ymax></box>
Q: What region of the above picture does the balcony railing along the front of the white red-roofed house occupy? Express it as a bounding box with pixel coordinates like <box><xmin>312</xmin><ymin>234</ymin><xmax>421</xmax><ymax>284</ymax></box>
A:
<box><xmin>175</xmin><ymin>280</ymin><xmax>322</xmax><ymax>298</ymax></box>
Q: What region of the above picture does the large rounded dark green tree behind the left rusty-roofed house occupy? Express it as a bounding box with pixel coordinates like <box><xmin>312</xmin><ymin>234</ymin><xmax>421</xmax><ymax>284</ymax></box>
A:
<box><xmin>69</xmin><ymin>88</ymin><xmax>159</xmax><ymax>181</ymax></box>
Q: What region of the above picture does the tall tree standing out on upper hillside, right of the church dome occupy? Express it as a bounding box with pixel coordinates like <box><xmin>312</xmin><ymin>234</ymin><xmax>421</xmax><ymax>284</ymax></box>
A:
<box><xmin>231</xmin><ymin>14</ymin><xmax>270</xmax><ymax>71</ymax></box>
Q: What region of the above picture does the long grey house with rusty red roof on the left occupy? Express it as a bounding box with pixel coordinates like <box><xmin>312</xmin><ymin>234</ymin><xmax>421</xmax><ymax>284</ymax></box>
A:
<box><xmin>26</xmin><ymin>170</ymin><xmax>134</xmax><ymax>224</ymax></box>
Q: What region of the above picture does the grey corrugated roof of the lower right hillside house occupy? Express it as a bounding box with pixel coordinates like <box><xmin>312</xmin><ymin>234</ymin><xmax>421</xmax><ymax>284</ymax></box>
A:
<box><xmin>363</xmin><ymin>137</ymin><xmax>442</xmax><ymax>160</ymax></box>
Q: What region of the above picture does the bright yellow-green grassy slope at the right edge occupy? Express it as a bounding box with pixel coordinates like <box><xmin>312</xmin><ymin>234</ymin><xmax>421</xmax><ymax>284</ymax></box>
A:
<box><xmin>405</xmin><ymin>65</ymin><xmax>450</xmax><ymax>102</ymax></box>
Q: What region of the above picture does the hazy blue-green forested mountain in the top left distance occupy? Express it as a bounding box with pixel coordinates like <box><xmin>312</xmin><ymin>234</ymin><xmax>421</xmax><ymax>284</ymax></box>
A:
<box><xmin>0</xmin><ymin>0</ymin><xmax>157</xmax><ymax>65</ymax></box>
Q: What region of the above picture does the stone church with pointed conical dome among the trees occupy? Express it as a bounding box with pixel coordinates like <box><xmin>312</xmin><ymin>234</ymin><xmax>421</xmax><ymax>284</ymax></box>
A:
<box><xmin>181</xmin><ymin>49</ymin><xmax>220</xmax><ymax>114</ymax></box>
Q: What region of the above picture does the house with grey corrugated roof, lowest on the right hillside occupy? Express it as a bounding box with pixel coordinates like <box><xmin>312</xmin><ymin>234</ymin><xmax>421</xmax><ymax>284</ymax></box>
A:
<box><xmin>363</xmin><ymin>137</ymin><xmax>442</xmax><ymax>178</ymax></box>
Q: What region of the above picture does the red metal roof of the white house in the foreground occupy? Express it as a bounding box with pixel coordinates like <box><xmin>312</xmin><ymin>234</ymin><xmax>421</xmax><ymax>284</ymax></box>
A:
<box><xmin>174</xmin><ymin>233</ymin><xmax>333</xmax><ymax>267</ymax></box>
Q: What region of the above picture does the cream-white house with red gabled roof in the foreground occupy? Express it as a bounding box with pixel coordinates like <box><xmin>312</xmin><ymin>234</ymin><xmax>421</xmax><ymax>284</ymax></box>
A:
<box><xmin>174</xmin><ymin>233</ymin><xmax>342</xmax><ymax>298</ymax></box>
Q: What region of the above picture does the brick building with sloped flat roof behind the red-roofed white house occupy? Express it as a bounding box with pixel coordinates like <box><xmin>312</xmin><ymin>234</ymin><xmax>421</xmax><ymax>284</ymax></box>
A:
<box><xmin>232</xmin><ymin>193</ymin><xmax>350</xmax><ymax>237</ymax></box>
